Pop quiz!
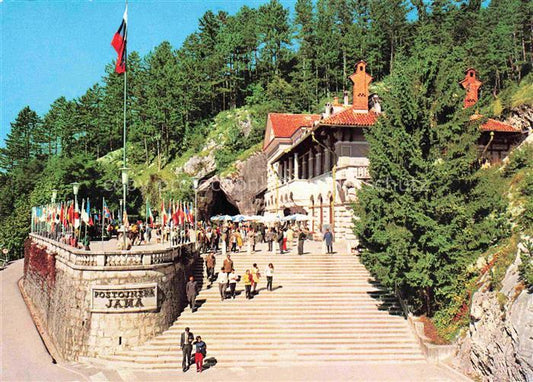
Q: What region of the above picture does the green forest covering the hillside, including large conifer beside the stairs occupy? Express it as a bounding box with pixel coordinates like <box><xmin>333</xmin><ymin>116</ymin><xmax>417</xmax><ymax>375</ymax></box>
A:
<box><xmin>0</xmin><ymin>0</ymin><xmax>533</xmax><ymax>335</ymax></box>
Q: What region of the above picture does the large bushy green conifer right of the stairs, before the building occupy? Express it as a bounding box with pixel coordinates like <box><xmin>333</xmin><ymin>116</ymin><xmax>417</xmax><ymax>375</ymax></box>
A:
<box><xmin>356</xmin><ymin>48</ymin><xmax>504</xmax><ymax>314</ymax></box>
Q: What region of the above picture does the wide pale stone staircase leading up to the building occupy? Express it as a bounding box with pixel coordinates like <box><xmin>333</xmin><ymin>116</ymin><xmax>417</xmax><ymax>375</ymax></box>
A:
<box><xmin>90</xmin><ymin>242</ymin><xmax>425</xmax><ymax>370</ymax></box>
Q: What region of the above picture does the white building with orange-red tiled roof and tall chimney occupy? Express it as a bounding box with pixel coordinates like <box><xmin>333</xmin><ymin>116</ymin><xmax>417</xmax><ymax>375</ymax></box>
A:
<box><xmin>263</xmin><ymin>61</ymin><xmax>381</xmax><ymax>240</ymax></box>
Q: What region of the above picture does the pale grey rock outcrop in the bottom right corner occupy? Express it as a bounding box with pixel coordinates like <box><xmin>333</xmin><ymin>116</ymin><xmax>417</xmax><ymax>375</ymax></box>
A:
<box><xmin>457</xmin><ymin>240</ymin><xmax>533</xmax><ymax>382</ymax></box>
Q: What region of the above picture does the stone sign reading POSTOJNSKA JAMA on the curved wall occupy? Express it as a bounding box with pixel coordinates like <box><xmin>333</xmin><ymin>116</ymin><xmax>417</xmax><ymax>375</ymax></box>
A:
<box><xmin>91</xmin><ymin>283</ymin><xmax>157</xmax><ymax>313</ymax></box>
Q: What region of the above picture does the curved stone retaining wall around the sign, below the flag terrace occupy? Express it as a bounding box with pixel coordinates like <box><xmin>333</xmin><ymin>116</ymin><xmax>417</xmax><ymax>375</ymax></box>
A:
<box><xmin>23</xmin><ymin>238</ymin><xmax>193</xmax><ymax>360</ymax></box>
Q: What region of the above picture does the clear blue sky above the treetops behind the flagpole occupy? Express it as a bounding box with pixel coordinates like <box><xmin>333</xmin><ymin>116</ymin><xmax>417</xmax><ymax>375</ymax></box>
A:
<box><xmin>0</xmin><ymin>0</ymin><xmax>296</xmax><ymax>146</ymax></box>
